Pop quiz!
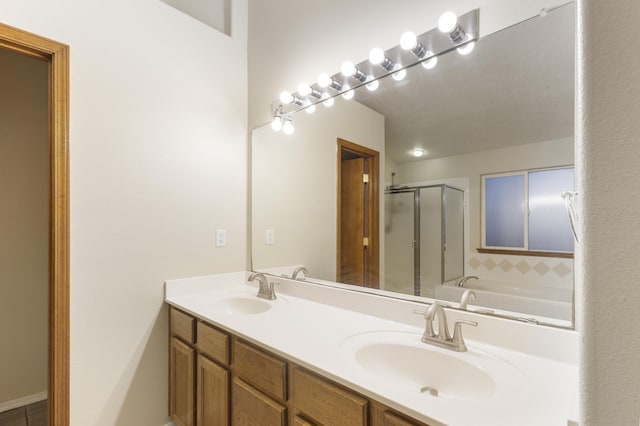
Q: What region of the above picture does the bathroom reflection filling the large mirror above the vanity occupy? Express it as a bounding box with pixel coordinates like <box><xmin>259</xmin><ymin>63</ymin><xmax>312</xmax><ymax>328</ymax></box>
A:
<box><xmin>252</xmin><ymin>4</ymin><xmax>574</xmax><ymax>324</ymax></box>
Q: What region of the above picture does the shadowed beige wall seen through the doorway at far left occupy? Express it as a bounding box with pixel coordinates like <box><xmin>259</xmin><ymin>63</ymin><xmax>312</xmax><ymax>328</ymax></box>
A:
<box><xmin>0</xmin><ymin>49</ymin><xmax>49</xmax><ymax>405</ymax></box>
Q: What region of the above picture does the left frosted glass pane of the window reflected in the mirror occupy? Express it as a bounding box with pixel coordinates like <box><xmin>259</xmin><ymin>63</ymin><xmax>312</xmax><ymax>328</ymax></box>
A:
<box><xmin>484</xmin><ymin>175</ymin><xmax>525</xmax><ymax>249</ymax></box>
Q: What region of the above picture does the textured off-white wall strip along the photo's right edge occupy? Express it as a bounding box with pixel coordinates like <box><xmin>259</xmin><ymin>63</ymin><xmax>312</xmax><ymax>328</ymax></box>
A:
<box><xmin>576</xmin><ymin>0</ymin><xmax>640</xmax><ymax>425</ymax></box>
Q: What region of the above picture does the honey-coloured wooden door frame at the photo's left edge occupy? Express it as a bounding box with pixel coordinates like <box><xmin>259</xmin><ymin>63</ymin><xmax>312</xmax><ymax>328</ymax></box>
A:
<box><xmin>0</xmin><ymin>24</ymin><xmax>69</xmax><ymax>426</ymax></box>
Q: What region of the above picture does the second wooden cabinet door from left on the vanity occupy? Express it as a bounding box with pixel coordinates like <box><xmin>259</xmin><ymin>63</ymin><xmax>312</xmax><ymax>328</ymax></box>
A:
<box><xmin>196</xmin><ymin>355</ymin><xmax>229</xmax><ymax>426</ymax></box>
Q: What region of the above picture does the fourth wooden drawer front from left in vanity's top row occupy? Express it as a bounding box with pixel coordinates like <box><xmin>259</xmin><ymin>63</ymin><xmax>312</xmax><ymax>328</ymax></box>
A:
<box><xmin>291</xmin><ymin>368</ymin><xmax>368</xmax><ymax>426</ymax></box>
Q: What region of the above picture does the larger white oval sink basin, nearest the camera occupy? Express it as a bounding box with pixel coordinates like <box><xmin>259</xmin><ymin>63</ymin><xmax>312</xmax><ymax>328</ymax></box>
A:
<box><xmin>342</xmin><ymin>331</ymin><xmax>517</xmax><ymax>400</ymax></box>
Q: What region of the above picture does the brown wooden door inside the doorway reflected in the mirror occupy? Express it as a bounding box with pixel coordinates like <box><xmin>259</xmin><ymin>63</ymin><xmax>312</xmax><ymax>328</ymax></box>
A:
<box><xmin>339</xmin><ymin>158</ymin><xmax>368</xmax><ymax>286</ymax></box>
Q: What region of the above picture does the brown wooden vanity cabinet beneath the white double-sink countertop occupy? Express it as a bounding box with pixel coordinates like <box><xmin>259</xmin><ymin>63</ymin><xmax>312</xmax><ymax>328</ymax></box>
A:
<box><xmin>169</xmin><ymin>307</ymin><xmax>428</xmax><ymax>426</ymax></box>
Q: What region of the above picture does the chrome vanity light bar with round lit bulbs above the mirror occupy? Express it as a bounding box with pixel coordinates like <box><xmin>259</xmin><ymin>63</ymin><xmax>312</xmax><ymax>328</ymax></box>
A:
<box><xmin>272</xmin><ymin>9</ymin><xmax>480</xmax><ymax>131</ymax></box>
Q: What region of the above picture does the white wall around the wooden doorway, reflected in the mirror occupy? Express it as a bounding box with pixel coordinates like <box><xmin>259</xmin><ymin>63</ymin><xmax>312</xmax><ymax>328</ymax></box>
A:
<box><xmin>251</xmin><ymin>98</ymin><xmax>384</xmax><ymax>281</ymax></box>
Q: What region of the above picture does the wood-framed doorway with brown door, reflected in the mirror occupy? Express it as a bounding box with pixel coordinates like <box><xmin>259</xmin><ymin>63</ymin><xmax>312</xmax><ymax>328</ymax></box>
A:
<box><xmin>336</xmin><ymin>139</ymin><xmax>380</xmax><ymax>288</ymax></box>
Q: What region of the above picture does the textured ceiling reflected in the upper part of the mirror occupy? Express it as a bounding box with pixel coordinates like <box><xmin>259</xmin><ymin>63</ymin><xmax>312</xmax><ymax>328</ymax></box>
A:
<box><xmin>355</xmin><ymin>4</ymin><xmax>575</xmax><ymax>163</ymax></box>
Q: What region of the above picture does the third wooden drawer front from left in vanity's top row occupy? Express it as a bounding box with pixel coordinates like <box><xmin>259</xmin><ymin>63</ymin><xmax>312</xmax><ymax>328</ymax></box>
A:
<box><xmin>233</xmin><ymin>340</ymin><xmax>287</xmax><ymax>401</ymax></box>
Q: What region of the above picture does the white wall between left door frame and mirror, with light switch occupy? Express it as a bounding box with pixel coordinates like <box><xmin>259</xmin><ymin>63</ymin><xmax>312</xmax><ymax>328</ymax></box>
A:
<box><xmin>0</xmin><ymin>0</ymin><xmax>247</xmax><ymax>426</ymax></box>
